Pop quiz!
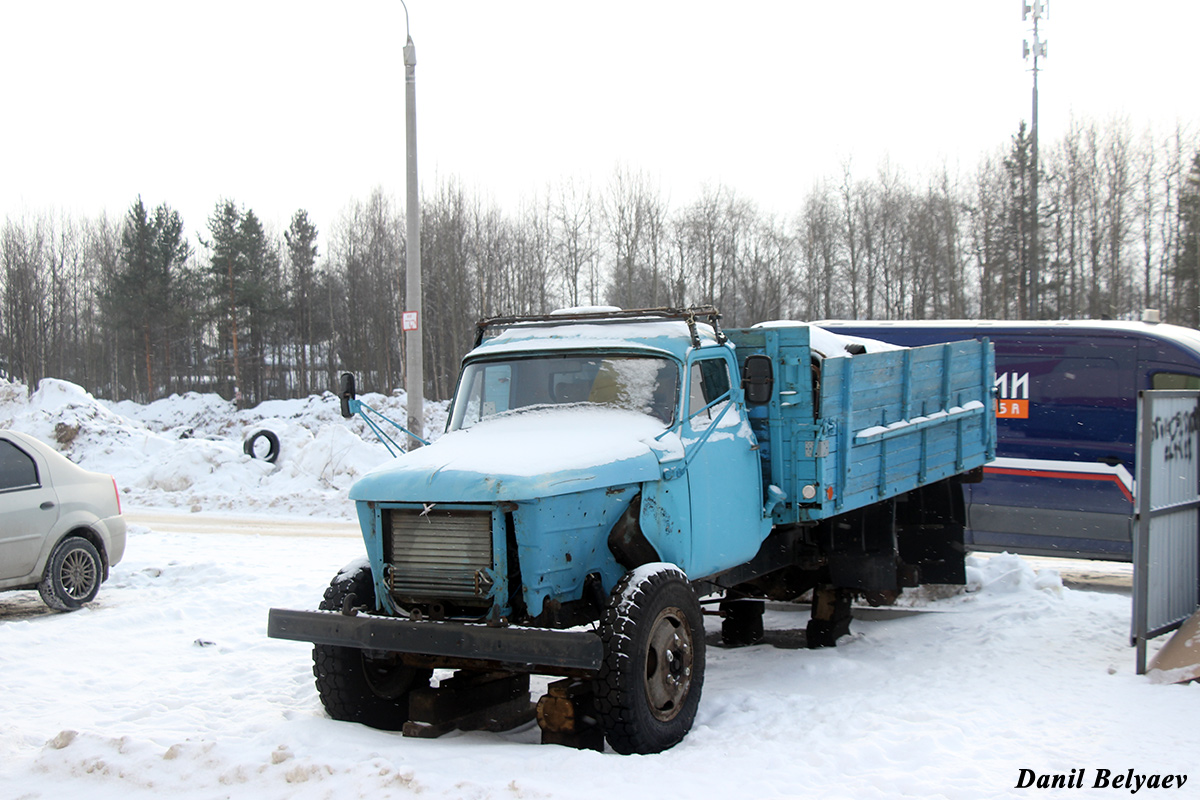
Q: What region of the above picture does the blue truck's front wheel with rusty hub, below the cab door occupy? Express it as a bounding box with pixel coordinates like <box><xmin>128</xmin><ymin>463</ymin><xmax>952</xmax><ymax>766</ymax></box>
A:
<box><xmin>595</xmin><ymin>564</ymin><xmax>704</xmax><ymax>754</ymax></box>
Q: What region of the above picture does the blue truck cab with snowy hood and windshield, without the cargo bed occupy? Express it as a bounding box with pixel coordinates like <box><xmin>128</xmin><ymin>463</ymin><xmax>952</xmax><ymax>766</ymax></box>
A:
<box><xmin>350</xmin><ymin>309</ymin><xmax>770</xmax><ymax>626</ymax></box>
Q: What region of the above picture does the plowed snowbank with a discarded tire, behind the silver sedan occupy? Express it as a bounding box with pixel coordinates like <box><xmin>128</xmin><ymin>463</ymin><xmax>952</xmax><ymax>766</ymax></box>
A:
<box><xmin>0</xmin><ymin>379</ymin><xmax>446</xmax><ymax>518</ymax></box>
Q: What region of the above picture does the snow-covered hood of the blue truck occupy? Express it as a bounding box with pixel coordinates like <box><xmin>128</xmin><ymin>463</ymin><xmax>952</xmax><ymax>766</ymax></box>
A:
<box><xmin>350</xmin><ymin>408</ymin><xmax>678</xmax><ymax>503</ymax></box>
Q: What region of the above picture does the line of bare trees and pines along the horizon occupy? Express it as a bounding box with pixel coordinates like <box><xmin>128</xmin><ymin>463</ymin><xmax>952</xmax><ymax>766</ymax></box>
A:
<box><xmin>0</xmin><ymin>117</ymin><xmax>1200</xmax><ymax>405</ymax></box>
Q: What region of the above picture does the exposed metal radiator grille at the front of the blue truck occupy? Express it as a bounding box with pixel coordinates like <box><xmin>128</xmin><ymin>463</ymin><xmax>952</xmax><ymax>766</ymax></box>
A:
<box><xmin>384</xmin><ymin>507</ymin><xmax>492</xmax><ymax>601</ymax></box>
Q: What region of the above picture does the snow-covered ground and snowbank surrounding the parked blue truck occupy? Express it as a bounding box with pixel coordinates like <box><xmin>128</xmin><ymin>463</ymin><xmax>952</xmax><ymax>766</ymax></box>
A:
<box><xmin>0</xmin><ymin>381</ymin><xmax>1200</xmax><ymax>800</ymax></box>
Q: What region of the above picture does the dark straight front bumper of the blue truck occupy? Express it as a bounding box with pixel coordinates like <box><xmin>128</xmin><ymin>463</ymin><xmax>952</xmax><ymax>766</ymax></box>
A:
<box><xmin>266</xmin><ymin>608</ymin><xmax>604</xmax><ymax>674</ymax></box>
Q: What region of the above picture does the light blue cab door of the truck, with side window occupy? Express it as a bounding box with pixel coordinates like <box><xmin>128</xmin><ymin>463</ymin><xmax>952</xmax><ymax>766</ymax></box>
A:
<box><xmin>680</xmin><ymin>350</ymin><xmax>764</xmax><ymax>577</ymax></box>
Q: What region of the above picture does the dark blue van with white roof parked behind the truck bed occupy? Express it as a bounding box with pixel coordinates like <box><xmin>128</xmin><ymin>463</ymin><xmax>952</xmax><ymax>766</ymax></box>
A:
<box><xmin>816</xmin><ymin>320</ymin><xmax>1200</xmax><ymax>561</ymax></box>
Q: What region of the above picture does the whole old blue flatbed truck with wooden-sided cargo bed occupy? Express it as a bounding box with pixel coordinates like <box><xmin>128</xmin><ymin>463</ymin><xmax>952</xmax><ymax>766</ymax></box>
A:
<box><xmin>269</xmin><ymin>308</ymin><xmax>996</xmax><ymax>753</ymax></box>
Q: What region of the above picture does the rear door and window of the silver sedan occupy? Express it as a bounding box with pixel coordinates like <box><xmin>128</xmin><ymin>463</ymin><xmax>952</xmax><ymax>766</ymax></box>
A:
<box><xmin>0</xmin><ymin>439</ymin><xmax>59</xmax><ymax>581</ymax></box>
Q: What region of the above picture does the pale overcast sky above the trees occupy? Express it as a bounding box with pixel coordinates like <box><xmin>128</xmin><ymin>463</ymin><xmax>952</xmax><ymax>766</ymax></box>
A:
<box><xmin>0</xmin><ymin>0</ymin><xmax>1200</xmax><ymax>245</ymax></box>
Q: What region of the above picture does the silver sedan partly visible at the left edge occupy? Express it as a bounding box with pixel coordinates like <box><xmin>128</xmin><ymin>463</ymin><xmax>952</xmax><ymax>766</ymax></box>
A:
<box><xmin>0</xmin><ymin>431</ymin><xmax>125</xmax><ymax>610</ymax></box>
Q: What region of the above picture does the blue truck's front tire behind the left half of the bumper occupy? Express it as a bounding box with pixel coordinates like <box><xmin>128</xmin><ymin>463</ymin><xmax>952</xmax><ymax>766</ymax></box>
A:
<box><xmin>312</xmin><ymin>566</ymin><xmax>433</xmax><ymax>730</ymax></box>
